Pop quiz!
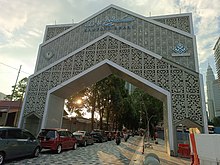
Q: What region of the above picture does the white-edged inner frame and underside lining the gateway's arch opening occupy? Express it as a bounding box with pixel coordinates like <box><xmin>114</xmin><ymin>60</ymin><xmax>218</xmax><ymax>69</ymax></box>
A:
<box><xmin>38</xmin><ymin>60</ymin><xmax>174</xmax><ymax>154</ymax></box>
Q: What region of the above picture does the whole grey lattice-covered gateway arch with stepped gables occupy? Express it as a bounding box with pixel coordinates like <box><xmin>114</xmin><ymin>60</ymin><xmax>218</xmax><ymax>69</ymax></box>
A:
<box><xmin>19</xmin><ymin>5</ymin><xmax>207</xmax><ymax>154</ymax></box>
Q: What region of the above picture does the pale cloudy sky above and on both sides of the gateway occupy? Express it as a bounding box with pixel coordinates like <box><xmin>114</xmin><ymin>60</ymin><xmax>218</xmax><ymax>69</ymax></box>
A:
<box><xmin>0</xmin><ymin>0</ymin><xmax>220</xmax><ymax>95</ymax></box>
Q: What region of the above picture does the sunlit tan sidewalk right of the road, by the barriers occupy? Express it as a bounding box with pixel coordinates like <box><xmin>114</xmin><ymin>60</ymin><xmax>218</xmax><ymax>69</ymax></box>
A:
<box><xmin>129</xmin><ymin>137</ymin><xmax>191</xmax><ymax>165</ymax></box>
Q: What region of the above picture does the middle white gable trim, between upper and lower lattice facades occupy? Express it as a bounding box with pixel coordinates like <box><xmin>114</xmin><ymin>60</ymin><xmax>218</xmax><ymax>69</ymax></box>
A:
<box><xmin>30</xmin><ymin>32</ymin><xmax>162</xmax><ymax>78</ymax></box>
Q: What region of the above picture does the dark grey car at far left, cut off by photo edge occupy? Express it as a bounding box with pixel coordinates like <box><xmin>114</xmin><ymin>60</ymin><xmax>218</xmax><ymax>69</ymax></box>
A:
<box><xmin>0</xmin><ymin>127</ymin><xmax>41</xmax><ymax>164</ymax></box>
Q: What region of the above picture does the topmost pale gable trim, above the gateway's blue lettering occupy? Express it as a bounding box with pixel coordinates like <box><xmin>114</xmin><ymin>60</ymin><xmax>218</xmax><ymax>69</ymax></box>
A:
<box><xmin>40</xmin><ymin>4</ymin><xmax>194</xmax><ymax>47</ymax></box>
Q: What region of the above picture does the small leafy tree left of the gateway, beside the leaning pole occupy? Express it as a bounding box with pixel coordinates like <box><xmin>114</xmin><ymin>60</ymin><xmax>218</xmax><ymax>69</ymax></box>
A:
<box><xmin>5</xmin><ymin>77</ymin><xmax>28</xmax><ymax>101</ymax></box>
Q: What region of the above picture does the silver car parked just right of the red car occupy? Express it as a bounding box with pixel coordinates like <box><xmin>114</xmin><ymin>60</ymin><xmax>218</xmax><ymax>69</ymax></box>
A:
<box><xmin>73</xmin><ymin>131</ymin><xmax>94</xmax><ymax>147</ymax></box>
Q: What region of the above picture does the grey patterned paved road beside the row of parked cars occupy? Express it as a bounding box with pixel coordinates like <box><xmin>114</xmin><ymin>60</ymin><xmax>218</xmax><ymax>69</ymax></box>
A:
<box><xmin>6</xmin><ymin>136</ymin><xmax>141</xmax><ymax>165</ymax></box>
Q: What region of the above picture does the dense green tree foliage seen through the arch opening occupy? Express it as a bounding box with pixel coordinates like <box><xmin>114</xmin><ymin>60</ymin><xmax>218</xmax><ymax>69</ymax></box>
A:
<box><xmin>67</xmin><ymin>75</ymin><xmax>163</xmax><ymax>130</ymax></box>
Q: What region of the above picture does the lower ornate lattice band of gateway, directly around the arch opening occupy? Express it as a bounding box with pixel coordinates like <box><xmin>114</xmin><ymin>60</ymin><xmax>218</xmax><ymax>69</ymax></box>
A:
<box><xmin>24</xmin><ymin>36</ymin><xmax>203</xmax><ymax>125</ymax></box>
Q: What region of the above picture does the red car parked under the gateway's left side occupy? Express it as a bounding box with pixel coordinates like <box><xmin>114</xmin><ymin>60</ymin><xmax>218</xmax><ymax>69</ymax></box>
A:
<box><xmin>38</xmin><ymin>128</ymin><xmax>77</xmax><ymax>154</ymax></box>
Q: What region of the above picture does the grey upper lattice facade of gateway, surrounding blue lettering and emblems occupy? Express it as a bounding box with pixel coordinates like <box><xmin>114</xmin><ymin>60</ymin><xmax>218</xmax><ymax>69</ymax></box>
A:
<box><xmin>36</xmin><ymin>7</ymin><xmax>196</xmax><ymax>71</ymax></box>
